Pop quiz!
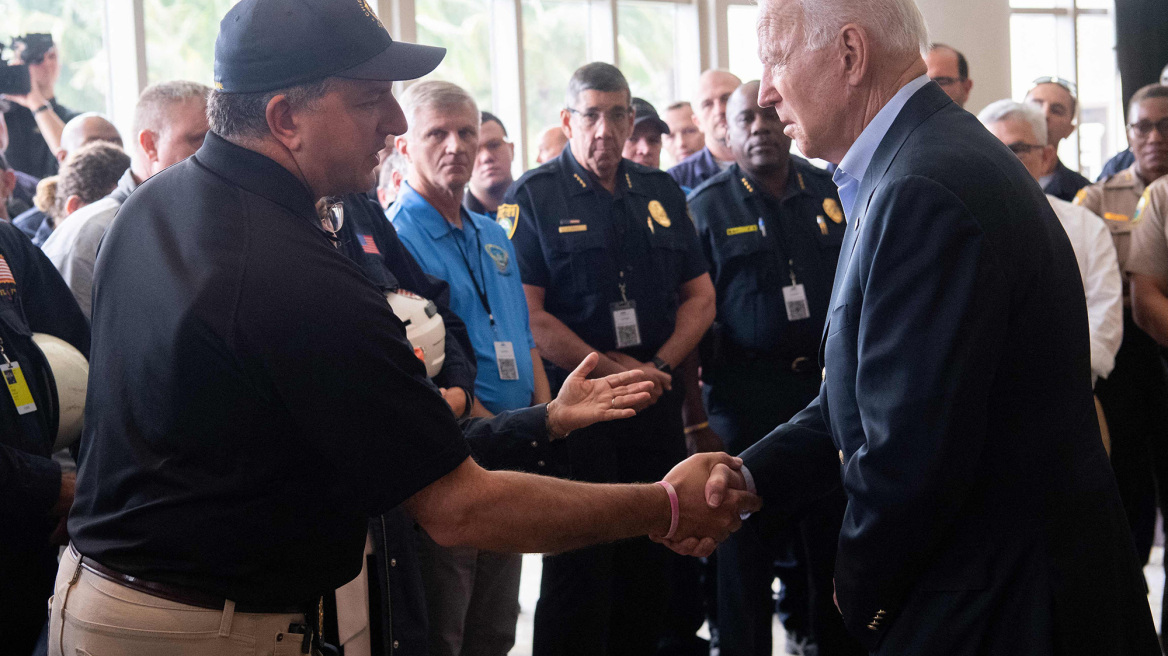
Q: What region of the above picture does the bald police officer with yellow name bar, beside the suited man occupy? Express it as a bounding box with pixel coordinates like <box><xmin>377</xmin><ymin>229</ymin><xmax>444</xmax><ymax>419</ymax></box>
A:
<box><xmin>689</xmin><ymin>82</ymin><xmax>862</xmax><ymax>656</ymax></box>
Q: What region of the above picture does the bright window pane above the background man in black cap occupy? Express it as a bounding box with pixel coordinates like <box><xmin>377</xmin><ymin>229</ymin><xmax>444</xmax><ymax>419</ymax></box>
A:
<box><xmin>617</xmin><ymin>0</ymin><xmax>679</xmax><ymax>113</ymax></box>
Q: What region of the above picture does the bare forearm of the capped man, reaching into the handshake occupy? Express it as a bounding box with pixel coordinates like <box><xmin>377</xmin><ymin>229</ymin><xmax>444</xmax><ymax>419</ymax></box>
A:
<box><xmin>408</xmin><ymin>460</ymin><xmax>669</xmax><ymax>553</ymax></box>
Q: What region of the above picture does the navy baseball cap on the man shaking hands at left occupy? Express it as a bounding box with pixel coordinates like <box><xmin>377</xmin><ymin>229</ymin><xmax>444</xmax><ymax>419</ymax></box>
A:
<box><xmin>215</xmin><ymin>0</ymin><xmax>446</xmax><ymax>93</ymax></box>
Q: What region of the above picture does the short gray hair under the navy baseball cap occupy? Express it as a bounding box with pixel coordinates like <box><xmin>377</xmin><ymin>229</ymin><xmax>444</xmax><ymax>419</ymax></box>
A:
<box><xmin>207</xmin><ymin>77</ymin><xmax>333</xmax><ymax>140</ymax></box>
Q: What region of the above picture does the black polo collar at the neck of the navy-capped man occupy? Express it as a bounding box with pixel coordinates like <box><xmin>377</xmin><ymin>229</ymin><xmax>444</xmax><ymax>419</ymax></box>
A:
<box><xmin>194</xmin><ymin>132</ymin><xmax>319</xmax><ymax>226</ymax></box>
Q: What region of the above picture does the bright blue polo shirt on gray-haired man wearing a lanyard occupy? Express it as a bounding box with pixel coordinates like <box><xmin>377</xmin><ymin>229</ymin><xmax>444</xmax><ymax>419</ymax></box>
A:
<box><xmin>388</xmin><ymin>182</ymin><xmax>535</xmax><ymax>413</ymax></box>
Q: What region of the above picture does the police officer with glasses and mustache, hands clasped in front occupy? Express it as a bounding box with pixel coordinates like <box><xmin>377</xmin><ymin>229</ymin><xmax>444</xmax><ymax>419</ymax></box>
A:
<box><xmin>499</xmin><ymin>63</ymin><xmax>714</xmax><ymax>656</ymax></box>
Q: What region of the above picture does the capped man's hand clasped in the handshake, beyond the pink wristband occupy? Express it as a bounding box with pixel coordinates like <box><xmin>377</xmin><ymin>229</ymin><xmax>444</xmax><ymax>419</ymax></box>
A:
<box><xmin>649</xmin><ymin>453</ymin><xmax>763</xmax><ymax>557</ymax></box>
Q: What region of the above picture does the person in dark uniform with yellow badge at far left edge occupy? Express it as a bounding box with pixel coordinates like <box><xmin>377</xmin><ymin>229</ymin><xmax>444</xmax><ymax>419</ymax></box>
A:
<box><xmin>0</xmin><ymin>222</ymin><xmax>89</xmax><ymax>654</ymax></box>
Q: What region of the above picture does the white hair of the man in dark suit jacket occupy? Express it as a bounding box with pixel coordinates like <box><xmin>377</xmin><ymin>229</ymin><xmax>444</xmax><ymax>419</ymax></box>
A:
<box><xmin>799</xmin><ymin>0</ymin><xmax>929</xmax><ymax>53</ymax></box>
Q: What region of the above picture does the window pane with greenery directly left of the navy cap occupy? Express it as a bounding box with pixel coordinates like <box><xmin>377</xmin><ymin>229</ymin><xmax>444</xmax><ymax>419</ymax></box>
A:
<box><xmin>142</xmin><ymin>0</ymin><xmax>235</xmax><ymax>86</ymax></box>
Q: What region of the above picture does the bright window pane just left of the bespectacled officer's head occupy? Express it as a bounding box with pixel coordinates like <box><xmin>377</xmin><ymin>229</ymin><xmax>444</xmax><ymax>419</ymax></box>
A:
<box><xmin>523</xmin><ymin>0</ymin><xmax>589</xmax><ymax>159</ymax></box>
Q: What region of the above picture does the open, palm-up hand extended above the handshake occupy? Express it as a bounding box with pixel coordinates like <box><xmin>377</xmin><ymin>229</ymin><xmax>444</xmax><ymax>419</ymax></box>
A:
<box><xmin>548</xmin><ymin>353</ymin><xmax>653</xmax><ymax>435</ymax></box>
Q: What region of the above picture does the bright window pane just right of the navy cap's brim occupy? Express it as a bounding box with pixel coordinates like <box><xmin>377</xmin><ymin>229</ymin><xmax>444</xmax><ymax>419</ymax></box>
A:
<box><xmin>415</xmin><ymin>0</ymin><xmax>492</xmax><ymax>110</ymax></box>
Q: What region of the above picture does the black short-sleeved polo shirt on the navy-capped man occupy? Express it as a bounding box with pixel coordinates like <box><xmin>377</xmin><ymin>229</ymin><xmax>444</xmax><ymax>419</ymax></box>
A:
<box><xmin>69</xmin><ymin>133</ymin><xmax>468</xmax><ymax>605</ymax></box>
